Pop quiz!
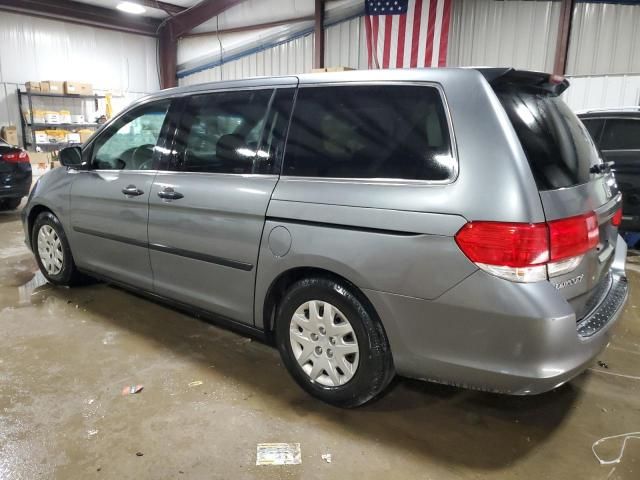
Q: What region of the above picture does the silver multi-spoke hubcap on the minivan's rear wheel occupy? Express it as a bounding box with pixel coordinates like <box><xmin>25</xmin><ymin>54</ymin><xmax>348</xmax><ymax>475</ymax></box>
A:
<box><xmin>289</xmin><ymin>300</ymin><xmax>360</xmax><ymax>387</ymax></box>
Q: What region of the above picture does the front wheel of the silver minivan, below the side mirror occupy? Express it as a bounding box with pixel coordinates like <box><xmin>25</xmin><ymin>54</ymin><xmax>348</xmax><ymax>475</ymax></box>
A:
<box><xmin>31</xmin><ymin>212</ymin><xmax>83</xmax><ymax>286</ymax></box>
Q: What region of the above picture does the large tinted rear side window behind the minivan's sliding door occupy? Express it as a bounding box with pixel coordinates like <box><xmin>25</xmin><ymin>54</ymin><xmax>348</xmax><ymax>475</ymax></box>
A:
<box><xmin>283</xmin><ymin>85</ymin><xmax>455</xmax><ymax>180</ymax></box>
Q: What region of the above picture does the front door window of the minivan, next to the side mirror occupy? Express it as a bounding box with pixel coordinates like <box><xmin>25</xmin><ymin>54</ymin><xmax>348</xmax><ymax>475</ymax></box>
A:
<box><xmin>91</xmin><ymin>101</ymin><xmax>169</xmax><ymax>170</ymax></box>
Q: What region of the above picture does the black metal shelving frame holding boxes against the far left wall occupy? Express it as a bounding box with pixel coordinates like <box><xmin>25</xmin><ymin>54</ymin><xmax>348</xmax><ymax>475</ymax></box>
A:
<box><xmin>18</xmin><ymin>89</ymin><xmax>105</xmax><ymax>150</ymax></box>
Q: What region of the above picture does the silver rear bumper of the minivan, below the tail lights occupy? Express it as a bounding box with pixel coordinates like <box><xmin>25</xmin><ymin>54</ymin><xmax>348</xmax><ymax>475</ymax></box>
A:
<box><xmin>365</xmin><ymin>237</ymin><xmax>628</xmax><ymax>395</ymax></box>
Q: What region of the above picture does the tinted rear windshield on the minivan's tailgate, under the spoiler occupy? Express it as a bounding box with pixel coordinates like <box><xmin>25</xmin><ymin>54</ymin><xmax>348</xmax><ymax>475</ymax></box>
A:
<box><xmin>497</xmin><ymin>90</ymin><xmax>601</xmax><ymax>190</ymax></box>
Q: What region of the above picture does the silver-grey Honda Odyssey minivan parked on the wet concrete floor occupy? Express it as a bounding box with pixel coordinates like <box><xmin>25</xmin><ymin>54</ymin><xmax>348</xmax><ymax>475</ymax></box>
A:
<box><xmin>23</xmin><ymin>68</ymin><xmax>627</xmax><ymax>407</ymax></box>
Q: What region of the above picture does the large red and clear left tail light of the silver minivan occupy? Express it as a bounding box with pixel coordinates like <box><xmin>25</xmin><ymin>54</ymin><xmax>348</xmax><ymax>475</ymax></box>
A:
<box><xmin>455</xmin><ymin>212</ymin><xmax>599</xmax><ymax>282</ymax></box>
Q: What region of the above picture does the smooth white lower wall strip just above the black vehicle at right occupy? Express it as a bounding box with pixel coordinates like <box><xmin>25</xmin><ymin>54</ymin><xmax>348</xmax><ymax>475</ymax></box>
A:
<box><xmin>563</xmin><ymin>75</ymin><xmax>640</xmax><ymax>111</ymax></box>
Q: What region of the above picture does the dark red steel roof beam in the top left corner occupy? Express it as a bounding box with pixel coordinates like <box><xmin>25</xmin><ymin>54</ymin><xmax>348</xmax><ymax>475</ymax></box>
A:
<box><xmin>0</xmin><ymin>0</ymin><xmax>160</xmax><ymax>36</ymax></box>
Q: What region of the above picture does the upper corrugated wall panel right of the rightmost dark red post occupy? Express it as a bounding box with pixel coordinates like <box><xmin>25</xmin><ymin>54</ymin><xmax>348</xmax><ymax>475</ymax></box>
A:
<box><xmin>567</xmin><ymin>3</ymin><xmax>640</xmax><ymax>75</ymax></box>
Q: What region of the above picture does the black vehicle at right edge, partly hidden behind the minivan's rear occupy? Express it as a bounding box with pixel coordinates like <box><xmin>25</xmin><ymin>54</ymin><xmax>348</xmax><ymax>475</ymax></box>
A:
<box><xmin>578</xmin><ymin>106</ymin><xmax>640</xmax><ymax>231</ymax></box>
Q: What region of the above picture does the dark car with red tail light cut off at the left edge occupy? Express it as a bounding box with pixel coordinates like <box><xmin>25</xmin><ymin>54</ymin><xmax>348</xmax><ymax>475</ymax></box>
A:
<box><xmin>0</xmin><ymin>139</ymin><xmax>31</xmax><ymax>210</ymax></box>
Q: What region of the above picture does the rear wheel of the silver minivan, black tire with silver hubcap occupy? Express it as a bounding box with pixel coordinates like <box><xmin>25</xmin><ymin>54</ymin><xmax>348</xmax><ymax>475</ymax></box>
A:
<box><xmin>276</xmin><ymin>277</ymin><xmax>395</xmax><ymax>408</ymax></box>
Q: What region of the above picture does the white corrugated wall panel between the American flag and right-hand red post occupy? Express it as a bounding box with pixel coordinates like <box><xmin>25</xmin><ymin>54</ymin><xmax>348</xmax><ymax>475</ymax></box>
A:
<box><xmin>447</xmin><ymin>0</ymin><xmax>560</xmax><ymax>71</ymax></box>
